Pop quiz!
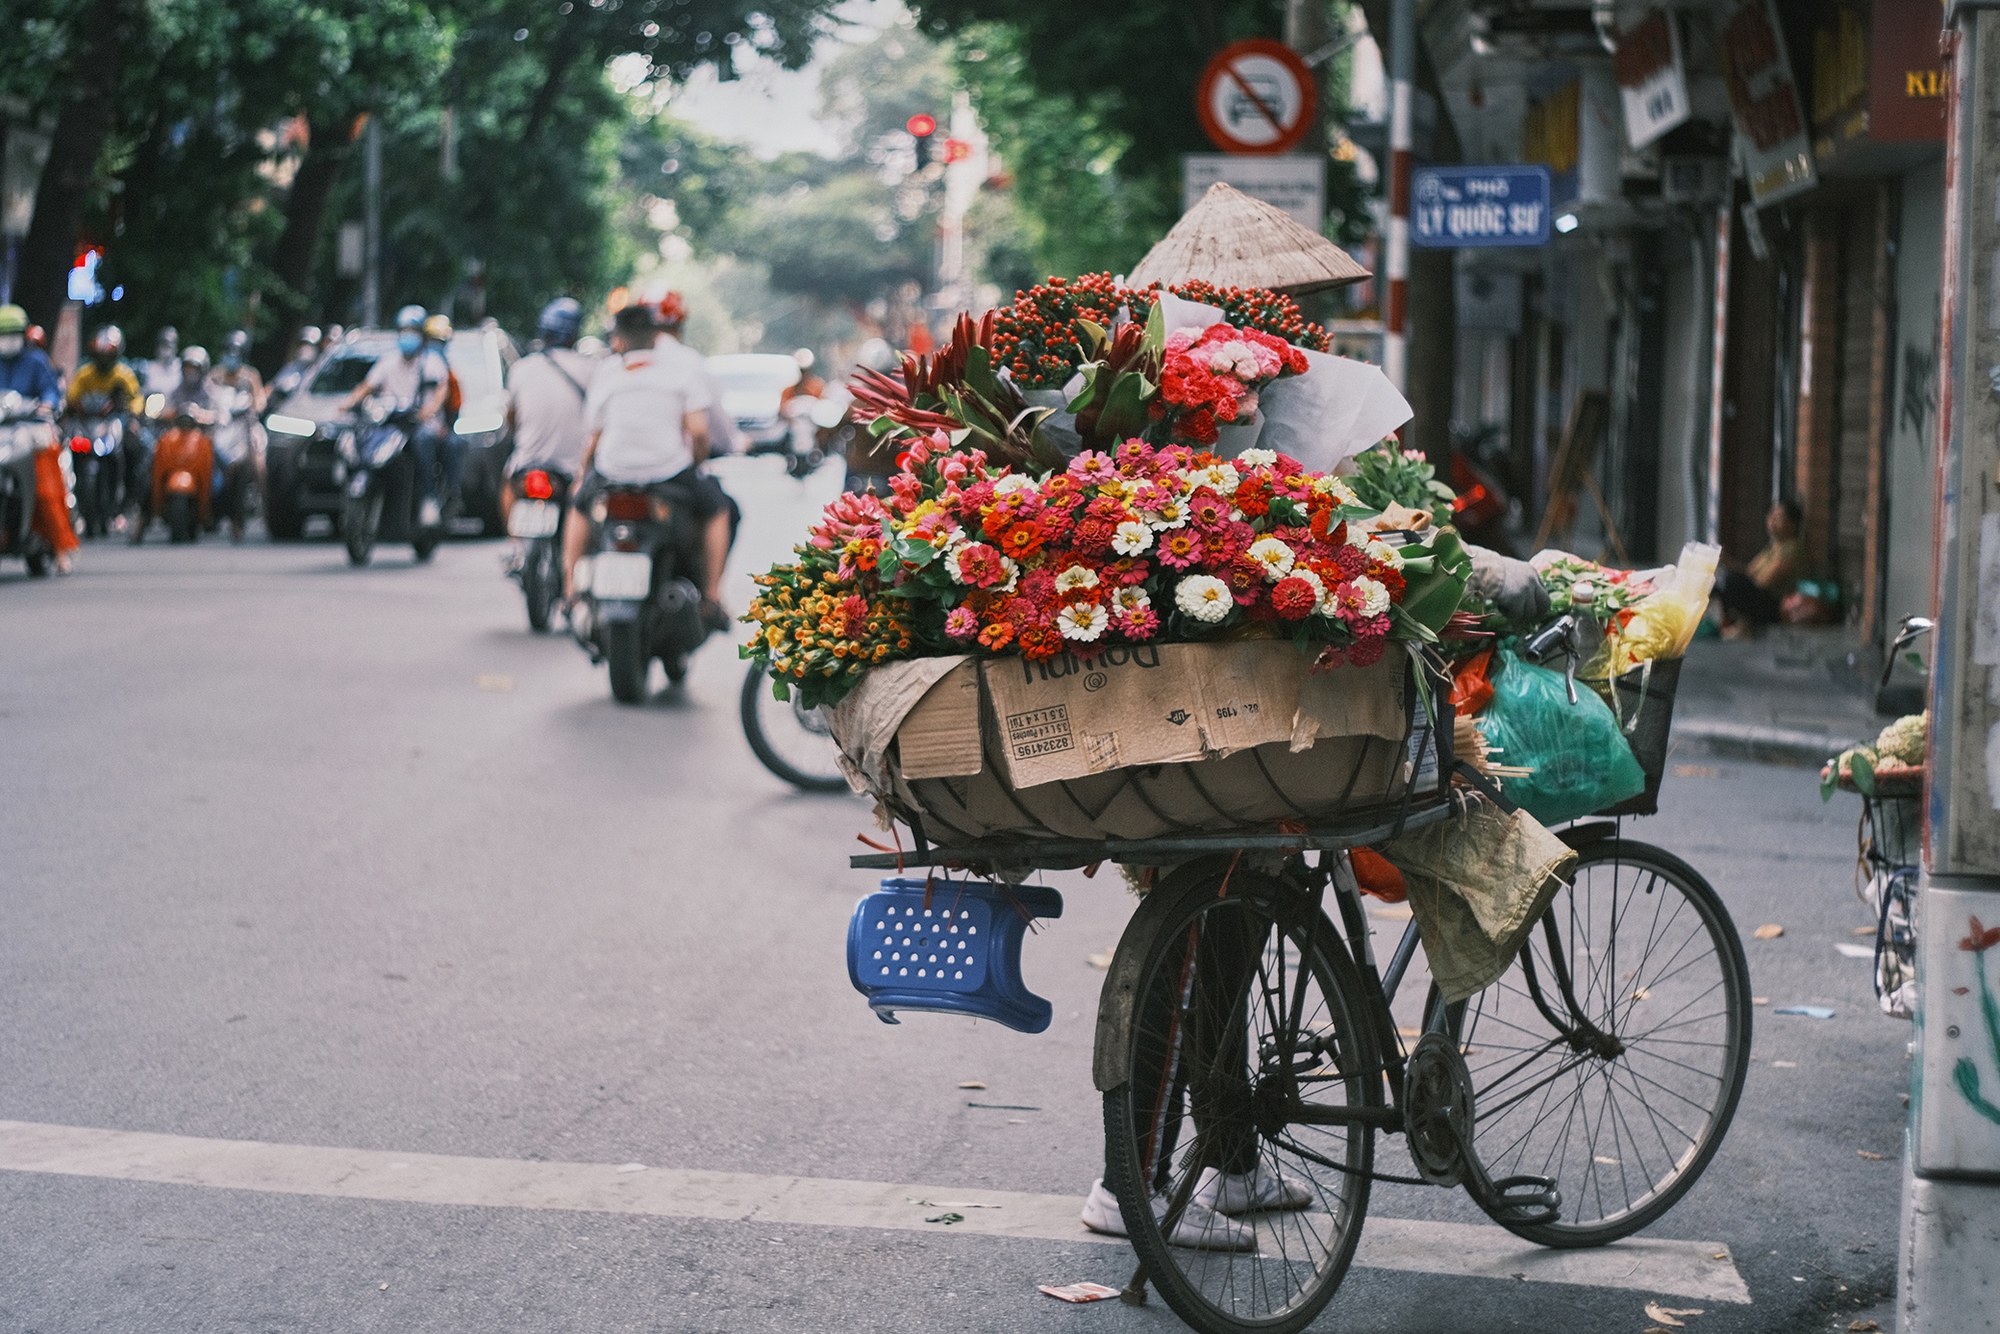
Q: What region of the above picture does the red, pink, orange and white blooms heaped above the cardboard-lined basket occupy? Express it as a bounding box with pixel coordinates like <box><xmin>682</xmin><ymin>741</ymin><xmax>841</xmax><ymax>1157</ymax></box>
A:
<box><xmin>744</xmin><ymin>436</ymin><xmax>1468</xmax><ymax>706</ymax></box>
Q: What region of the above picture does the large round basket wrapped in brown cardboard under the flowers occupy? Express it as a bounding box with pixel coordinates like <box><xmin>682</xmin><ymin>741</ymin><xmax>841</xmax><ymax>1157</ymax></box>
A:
<box><xmin>832</xmin><ymin>640</ymin><xmax>1438</xmax><ymax>844</ymax></box>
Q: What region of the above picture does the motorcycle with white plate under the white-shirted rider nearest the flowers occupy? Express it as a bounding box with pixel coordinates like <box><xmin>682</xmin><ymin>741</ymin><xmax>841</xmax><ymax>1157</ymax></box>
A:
<box><xmin>570</xmin><ymin>486</ymin><xmax>710</xmax><ymax>704</ymax></box>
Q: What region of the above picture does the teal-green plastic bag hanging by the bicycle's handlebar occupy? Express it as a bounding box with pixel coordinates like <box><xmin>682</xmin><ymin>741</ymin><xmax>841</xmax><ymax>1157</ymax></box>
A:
<box><xmin>1478</xmin><ymin>650</ymin><xmax>1646</xmax><ymax>824</ymax></box>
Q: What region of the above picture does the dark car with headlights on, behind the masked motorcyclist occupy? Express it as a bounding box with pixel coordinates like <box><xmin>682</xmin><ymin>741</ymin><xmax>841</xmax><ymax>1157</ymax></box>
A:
<box><xmin>264</xmin><ymin>320</ymin><xmax>520</xmax><ymax>542</ymax></box>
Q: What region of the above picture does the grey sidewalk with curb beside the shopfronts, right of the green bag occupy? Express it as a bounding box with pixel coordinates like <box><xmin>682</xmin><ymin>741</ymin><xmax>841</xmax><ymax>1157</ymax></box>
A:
<box><xmin>1674</xmin><ymin>626</ymin><xmax>1888</xmax><ymax>766</ymax></box>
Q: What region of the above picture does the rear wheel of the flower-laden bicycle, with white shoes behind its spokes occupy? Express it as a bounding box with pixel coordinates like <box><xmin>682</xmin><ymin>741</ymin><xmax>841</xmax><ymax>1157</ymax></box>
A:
<box><xmin>1104</xmin><ymin>858</ymin><xmax>1382</xmax><ymax>1334</ymax></box>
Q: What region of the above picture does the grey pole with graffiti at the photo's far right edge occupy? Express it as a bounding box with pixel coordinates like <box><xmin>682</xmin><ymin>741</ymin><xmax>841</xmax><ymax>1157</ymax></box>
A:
<box><xmin>1896</xmin><ymin>0</ymin><xmax>2000</xmax><ymax>1334</ymax></box>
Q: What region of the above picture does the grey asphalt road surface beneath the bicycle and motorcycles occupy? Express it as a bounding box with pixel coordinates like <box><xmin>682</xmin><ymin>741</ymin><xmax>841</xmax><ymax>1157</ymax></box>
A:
<box><xmin>0</xmin><ymin>464</ymin><xmax>1910</xmax><ymax>1334</ymax></box>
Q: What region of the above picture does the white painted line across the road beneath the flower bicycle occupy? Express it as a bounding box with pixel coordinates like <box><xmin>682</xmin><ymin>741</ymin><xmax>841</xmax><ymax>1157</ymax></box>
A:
<box><xmin>0</xmin><ymin>1120</ymin><xmax>1750</xmax><ymax>1302</ymax></box>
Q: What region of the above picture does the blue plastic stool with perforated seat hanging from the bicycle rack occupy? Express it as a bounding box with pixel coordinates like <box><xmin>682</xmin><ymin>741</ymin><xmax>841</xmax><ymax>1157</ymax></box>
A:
<box><xmin>848</xmin><ymin>880</ymin><xmax>1062</xmax><ymax>1032</ymax></box>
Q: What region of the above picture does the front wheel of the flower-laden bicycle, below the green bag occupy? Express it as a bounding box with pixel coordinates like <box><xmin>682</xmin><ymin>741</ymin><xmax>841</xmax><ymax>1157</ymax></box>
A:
<box><xmin>1426</xmin><ymin>836</ymin><xmax>1750</xmax><ymax>1248</ymax></box>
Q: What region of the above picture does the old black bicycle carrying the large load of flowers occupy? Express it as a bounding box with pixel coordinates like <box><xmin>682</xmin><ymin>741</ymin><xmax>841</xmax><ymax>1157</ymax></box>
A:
<box><xmin>850</xmin><ymin>644</ymin><xmax>1750</xmax><ymax>1334</ymax></box>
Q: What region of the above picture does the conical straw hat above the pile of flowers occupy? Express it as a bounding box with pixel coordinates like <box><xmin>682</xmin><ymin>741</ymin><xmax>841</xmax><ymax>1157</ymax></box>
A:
<box><xmin>1126</xmin><ymin>180</ymin><xmax>1368</xmax><ymax>294</ymax></box>
